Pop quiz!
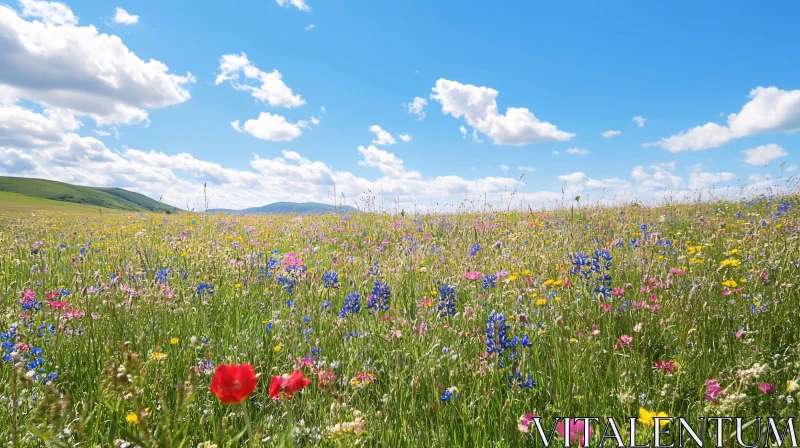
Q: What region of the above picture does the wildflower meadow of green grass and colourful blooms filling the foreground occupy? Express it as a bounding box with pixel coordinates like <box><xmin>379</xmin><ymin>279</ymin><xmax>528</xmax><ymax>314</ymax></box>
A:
<box><xmin>0</xmin><ymin>195</ymin><xmax>800</xmax><ymax>447</ymax></box>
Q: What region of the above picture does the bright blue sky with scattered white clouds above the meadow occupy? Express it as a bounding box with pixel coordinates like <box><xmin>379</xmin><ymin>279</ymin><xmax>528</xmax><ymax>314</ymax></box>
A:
<box><xmin>0</xmin><ymin>0</ymin><xmax>800</xmax><ymax>210</ymax></box>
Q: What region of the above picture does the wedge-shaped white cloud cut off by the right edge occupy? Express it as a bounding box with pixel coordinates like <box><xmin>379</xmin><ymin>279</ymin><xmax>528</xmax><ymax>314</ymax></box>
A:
<box><xmin>643</xmin><ymin>87</ymin><xmax>800</xmax><ymax>152</ymax></box>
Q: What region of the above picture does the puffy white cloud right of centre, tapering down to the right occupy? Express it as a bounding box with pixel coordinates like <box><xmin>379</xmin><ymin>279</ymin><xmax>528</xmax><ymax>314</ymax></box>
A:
<box><xmin>431</xmin><ymin>79</ymin><xmax>574</xmax><ymax>146</ymax></box>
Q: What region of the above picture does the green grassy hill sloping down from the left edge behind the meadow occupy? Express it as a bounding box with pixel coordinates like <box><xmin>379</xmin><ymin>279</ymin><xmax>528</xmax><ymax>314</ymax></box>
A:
<box><xmin>0</xmin><ymin>176</ymin><xmax>181</xmax><ymax>213</ymax></box>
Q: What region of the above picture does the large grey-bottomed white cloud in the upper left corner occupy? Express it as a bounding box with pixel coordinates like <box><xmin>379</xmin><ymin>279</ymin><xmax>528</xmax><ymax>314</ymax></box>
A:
<box><xmin>0</xmin><ymin>0</ymin><xmax>194</xmax><ymax>126</ymax></box>
